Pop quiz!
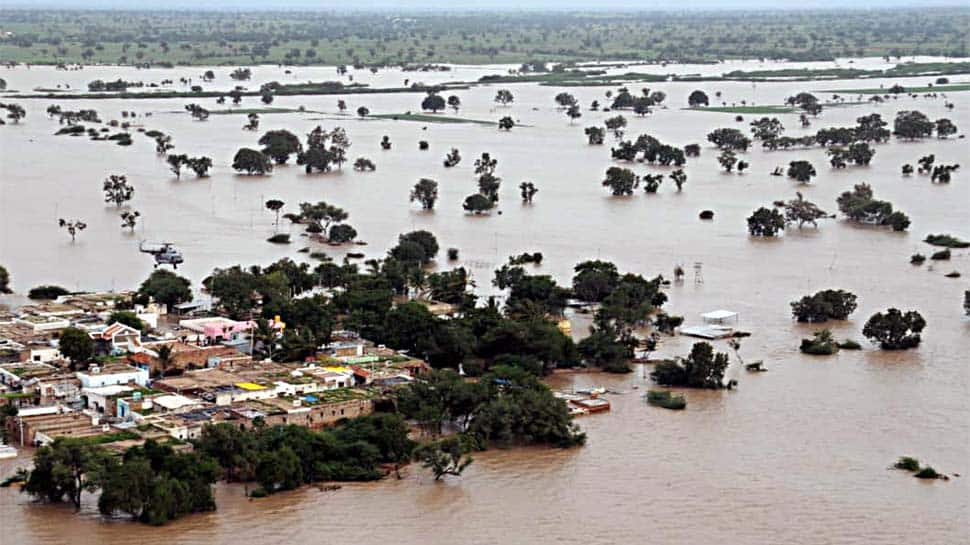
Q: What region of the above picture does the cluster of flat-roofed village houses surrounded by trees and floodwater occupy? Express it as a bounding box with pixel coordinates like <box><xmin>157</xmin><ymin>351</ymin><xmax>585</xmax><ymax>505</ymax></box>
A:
<box><xmin>0</xmin><ymin>293</ymin><xmax>430</xmax><ymax>451</ymax></box>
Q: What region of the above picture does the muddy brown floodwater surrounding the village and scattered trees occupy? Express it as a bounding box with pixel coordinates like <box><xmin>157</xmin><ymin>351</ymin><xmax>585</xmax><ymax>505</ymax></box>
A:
<box><xmin>0</xmin><ymin>59</ymin><xmax>970</xmax><ymax>545</ymax></box>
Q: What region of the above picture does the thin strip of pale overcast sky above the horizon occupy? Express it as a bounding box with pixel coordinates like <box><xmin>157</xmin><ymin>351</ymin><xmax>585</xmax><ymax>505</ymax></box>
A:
<box><xmin>9</xmin><ymin>0</ymin><xmax>968</xmax><ymax>11</ymax></box>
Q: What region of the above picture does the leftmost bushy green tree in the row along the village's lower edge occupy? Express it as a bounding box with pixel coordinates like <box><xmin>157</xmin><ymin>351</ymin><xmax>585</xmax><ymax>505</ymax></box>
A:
<box><xmin>24</xmin><ymin>437</ymin><xmax>112</xmax><ymax>510</ymax></box>
